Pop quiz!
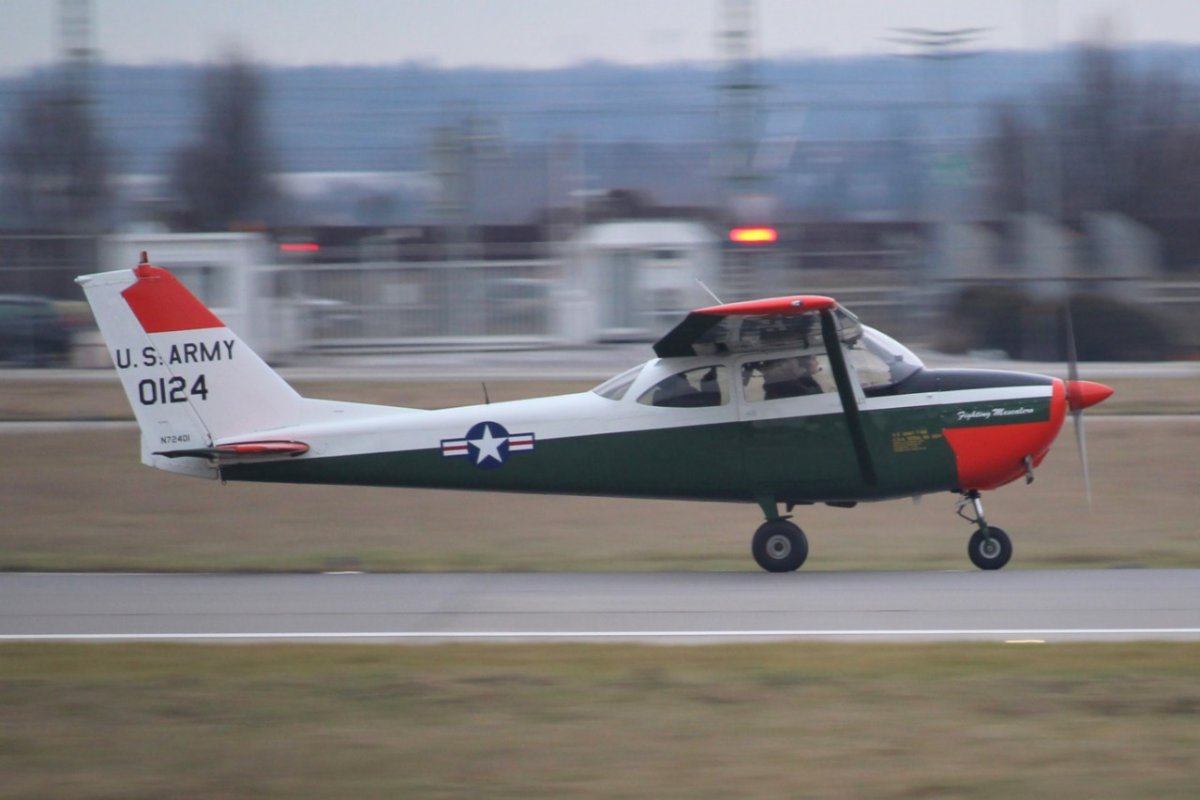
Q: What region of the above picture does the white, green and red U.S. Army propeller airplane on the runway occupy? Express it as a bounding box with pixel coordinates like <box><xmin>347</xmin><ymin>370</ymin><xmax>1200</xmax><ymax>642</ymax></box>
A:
<box><xmin>77</xmin><ymin>253</ymin><xmax>1112</xmax><ymax>572</ymax></box>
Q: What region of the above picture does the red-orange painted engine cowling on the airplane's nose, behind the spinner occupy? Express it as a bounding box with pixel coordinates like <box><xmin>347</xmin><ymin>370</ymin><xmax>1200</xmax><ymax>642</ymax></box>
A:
<box><xmin>942</xmin><ymin>378</ymin><xmax>1067</xmax><ymax>492</ymax></box>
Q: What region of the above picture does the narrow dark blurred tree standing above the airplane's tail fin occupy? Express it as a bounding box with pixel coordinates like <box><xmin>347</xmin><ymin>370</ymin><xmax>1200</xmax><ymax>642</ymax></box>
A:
<box><xmin>170</xmin><ymin>55</ymin><xmax>278</xmax><ymax>230</ymax></box>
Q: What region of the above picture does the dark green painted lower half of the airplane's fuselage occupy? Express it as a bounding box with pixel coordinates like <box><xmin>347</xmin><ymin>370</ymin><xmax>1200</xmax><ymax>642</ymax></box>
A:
<box><xmin>221</xmin><ymin>397</ymin><xmax>1050</xmax><ymax>503</ymax></box>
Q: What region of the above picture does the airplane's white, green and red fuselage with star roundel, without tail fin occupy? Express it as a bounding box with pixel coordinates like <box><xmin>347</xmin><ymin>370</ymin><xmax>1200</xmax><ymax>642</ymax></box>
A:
<box><xmin>221</xmin><ymin>355</ymin><xmax>1067</xmax><ymax>503</ymax></box>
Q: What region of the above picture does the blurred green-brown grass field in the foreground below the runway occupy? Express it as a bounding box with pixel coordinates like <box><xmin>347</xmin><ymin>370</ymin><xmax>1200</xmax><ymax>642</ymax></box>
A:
<box><xmin>0</xmin><ymin>643</ymin><xmax>1200</xmax><ymax>800</ymax></box>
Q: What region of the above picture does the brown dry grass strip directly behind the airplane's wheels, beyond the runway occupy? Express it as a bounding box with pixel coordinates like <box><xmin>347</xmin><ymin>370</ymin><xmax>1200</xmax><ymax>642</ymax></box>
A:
<box><xmin>0</xmin><ymin>420</ymin><xmax>1200</xmax><ymax>571</ymax></box>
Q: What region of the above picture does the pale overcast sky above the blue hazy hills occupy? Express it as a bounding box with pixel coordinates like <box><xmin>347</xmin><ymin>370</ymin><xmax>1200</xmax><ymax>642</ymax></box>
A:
<box><xmin>0</xmin><ymin>0</ymin><xmax>1200</xmax><ymax>74</ymax></box>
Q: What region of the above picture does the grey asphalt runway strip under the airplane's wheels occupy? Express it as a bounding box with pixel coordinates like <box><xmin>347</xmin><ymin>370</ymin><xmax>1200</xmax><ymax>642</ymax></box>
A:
<box><xmin>0</xmin><ymin>570</ymin><xmax>1200</xmax><ymax>643</ymax></box>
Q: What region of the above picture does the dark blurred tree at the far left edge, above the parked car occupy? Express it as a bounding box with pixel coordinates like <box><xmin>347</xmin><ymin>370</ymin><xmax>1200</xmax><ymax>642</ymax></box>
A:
<box><xmin>2</xmin><ymin>82</ymin><xmax>110</xmax><ymax>234</ymax></box>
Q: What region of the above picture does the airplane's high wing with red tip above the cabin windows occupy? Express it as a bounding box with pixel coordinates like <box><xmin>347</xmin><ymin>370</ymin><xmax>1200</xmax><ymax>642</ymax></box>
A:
<box><xmin>654</xmin><ymin>295</ymin><xmax>840</xmax><ymax>359</ymax></box>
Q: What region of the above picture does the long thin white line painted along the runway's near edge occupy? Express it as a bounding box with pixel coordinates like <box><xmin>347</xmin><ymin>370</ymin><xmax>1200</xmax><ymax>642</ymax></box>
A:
<box><xmin>0</xmin><ymin>627</ymin><xmax>1200</xmax><ymax>642</ymax></box>
